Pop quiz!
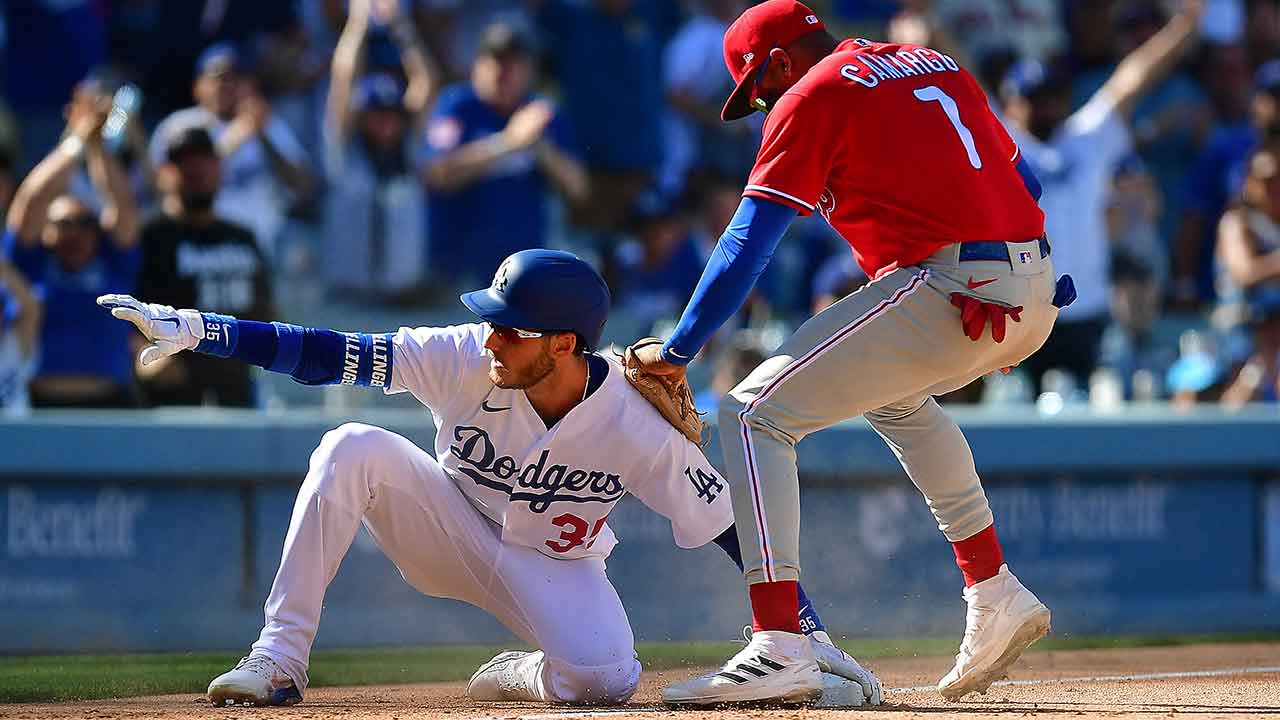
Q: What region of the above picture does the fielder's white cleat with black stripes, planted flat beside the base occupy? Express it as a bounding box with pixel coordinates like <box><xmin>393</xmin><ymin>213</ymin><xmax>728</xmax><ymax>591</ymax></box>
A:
<box><xmin>662</xmin><ymin>630</ymin><xmax>823</xmax><ymax>705</ymax></box>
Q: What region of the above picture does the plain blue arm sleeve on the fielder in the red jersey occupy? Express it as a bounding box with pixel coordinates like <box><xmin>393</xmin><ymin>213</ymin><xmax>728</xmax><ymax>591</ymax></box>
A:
<box><xmin>662</xmin><ymin>197</ymin><xmax>796</xmax><ymax>365</ymax></box>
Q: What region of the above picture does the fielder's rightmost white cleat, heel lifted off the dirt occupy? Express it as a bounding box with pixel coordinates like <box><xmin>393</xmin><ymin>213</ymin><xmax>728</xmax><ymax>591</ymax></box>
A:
<box><xmin>938</xmin><ymin>565</ymin><xmax>1050</xmax><ymax>701</ymax></box>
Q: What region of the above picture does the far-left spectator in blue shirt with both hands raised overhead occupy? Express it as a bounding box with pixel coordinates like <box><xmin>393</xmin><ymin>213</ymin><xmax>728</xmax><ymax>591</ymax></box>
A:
<box><xmin>0</xmin><ymin>94</ymin><xmax>138</xmax><ymax>407</ymax></box>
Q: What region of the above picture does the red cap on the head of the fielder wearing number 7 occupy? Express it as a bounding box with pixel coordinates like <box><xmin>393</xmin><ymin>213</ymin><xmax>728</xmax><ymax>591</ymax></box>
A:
<box><xmin>721</xmin><ymin>0</ymin><xmax>827</xmax><ymax>122</ymax></box>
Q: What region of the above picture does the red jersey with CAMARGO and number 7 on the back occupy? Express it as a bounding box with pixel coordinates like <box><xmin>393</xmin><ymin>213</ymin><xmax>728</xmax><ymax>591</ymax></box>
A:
<box><xmin>744</xmin><ymin>40</ymin><xmax>1044</xmax><ymax>277</ymax></box>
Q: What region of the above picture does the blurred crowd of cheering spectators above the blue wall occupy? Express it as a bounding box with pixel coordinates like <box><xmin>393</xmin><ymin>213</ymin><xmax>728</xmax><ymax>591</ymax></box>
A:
<box><xmin>0</xmin><ymin>0</ymin><xmax>1280</xmax><ymax>414</ymax></box>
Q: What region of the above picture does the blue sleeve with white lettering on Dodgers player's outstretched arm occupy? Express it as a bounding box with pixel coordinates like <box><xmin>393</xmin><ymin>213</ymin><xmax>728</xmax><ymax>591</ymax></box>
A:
<box><xmin>196</xmin><ymin>313</ymin><xmax>392</xmax><ymax>387</ymax></box>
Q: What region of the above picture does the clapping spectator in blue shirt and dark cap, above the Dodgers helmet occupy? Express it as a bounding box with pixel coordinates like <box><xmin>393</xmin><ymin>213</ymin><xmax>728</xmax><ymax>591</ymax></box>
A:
<box><xmin>421</xmin><ymin>24</ymin><xmax>589</xmax><ymax>286</ymax></box>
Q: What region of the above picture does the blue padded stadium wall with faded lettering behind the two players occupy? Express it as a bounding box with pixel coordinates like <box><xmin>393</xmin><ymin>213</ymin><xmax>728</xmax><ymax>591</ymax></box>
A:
<box><xmin>0</xmin><ymin>407</ymin><xmax>1280</xmax><ymax>653</ymax></box>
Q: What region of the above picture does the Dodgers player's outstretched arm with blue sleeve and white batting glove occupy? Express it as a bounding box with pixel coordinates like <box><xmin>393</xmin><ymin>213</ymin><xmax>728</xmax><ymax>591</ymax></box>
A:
<box><xmin>97</xmin><ymin>295</ymin><xmax>392</xmax><ymax>388</ymax></box>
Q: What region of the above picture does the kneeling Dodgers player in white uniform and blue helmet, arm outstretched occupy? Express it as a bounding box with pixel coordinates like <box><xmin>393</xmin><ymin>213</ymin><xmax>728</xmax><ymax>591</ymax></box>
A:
<box><xmin>99</xmin><ymin>250</ymin><xmax>881</xmax><ymax>705</ymax></box>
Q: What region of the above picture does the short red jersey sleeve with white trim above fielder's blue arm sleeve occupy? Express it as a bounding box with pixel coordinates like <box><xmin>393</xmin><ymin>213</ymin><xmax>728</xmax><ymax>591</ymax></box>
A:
<box><xmin>742</xmin><ymin>92</ymin><xmax>844</xmax><ymax>215</ymax></box>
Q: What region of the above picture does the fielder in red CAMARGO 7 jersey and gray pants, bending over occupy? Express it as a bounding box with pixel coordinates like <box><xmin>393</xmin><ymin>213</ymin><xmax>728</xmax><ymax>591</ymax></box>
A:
<box><xmin>637</xmin><ymin>0</ymin><xmax>1074</xmax><ymax>703</ymax></box>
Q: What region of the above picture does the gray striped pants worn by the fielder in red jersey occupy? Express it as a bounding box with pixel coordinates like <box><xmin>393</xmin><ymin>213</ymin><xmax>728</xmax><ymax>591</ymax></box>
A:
<box><xmin>719</xmin><ymin>243</ymin><xmax>1057</xmax><ymax>583</ymax></box>
